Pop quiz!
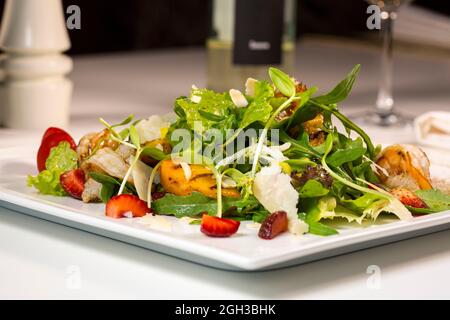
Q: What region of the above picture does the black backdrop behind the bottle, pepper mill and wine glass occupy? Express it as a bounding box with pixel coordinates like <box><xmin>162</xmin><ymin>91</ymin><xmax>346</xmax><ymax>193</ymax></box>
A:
<box><xmin>0</xmin><ymin>0</ymin><xmax>450</xmax><ymax>54</ymax></box>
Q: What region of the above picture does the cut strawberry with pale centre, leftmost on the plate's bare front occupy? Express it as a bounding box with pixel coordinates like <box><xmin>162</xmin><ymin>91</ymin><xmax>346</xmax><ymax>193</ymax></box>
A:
<box><xmin>105</xmin><ymin>194</ymin><xmax>151</xmax><ymax>219</ymax></box>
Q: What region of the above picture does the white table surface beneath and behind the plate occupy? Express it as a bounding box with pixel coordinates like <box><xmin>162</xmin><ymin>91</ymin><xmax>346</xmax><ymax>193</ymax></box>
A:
<box><xmin>0</xmin><ymin>42</ymin><xmax>450</xmax><ymax>299</ymax></box>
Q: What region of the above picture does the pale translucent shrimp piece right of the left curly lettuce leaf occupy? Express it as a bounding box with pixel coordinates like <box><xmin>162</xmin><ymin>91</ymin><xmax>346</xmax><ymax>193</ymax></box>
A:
<box><xmin>81</xmin><ymin>147</ymin><xmax>131</xmax><ymax>182</ymax></box>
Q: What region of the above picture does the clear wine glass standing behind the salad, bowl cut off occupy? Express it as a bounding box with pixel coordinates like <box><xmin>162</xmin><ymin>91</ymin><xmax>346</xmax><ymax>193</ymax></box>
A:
<box><xmin>363</xmin><ymin>0</ymin><xmax>412</xmax><ymax>126</ymax></box>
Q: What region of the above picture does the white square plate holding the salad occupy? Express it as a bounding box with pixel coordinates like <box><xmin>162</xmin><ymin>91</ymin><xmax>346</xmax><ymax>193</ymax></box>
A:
<box><xmin>0</xmin><ymin>148</ymin><xmax>450</xmax><ymax>271</ymax></box>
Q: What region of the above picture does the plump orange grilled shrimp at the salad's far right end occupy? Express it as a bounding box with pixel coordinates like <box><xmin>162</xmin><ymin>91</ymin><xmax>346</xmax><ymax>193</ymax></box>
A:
<box><xmin>376</xmin><ymin>144</ymin><xmax>433</xmax><ymax>191</ymax></box>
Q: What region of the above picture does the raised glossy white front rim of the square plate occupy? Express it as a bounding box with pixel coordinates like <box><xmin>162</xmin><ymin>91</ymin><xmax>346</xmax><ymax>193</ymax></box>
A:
<box><xmin>0</xmin><ymin>186</ymin><xmax>450</xmax><ymax>271</ymax></box>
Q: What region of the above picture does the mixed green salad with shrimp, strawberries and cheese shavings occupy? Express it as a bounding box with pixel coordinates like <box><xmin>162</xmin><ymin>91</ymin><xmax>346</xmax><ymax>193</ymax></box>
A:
<box><xmin>28</xmin><ymin>65</ymin><xmax>450</xmax><ymax>239</ymax></box>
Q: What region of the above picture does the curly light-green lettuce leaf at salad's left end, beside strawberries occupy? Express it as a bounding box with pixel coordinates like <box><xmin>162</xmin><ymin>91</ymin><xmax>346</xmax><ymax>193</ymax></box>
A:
<box><xmin>27</xmin><ymin>141</ymin><xmax>77</xmax><ymax>196</ymax></box>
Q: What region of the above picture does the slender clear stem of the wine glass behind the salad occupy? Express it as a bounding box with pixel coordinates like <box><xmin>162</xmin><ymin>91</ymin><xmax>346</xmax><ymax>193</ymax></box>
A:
<box><xmin>376</xmin><ymin>12</ymin><xmax>395</xmax><ymax>117</ymax></box>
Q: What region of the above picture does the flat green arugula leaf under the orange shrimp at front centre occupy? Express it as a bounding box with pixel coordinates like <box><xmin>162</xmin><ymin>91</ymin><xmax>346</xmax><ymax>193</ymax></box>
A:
<box><xmin>152</xmin><ymin>192</ymin><xmax>260</xmax><ymax>218</ymax></box>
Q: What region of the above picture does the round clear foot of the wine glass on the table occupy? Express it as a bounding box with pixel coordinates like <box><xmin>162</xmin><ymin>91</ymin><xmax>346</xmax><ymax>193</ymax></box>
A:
<box><xmin>350</xmin><ymin>111</ymin><xmax>412</xmax><ymax>127</ymax></box>
